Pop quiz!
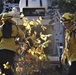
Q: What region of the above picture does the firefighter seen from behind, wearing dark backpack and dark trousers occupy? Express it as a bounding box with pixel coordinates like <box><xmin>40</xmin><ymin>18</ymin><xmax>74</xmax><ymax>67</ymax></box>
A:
<box><xmin>0</xmin><ymin>13</ymin><xmax>25</xmax><ymax>75</ymax></box>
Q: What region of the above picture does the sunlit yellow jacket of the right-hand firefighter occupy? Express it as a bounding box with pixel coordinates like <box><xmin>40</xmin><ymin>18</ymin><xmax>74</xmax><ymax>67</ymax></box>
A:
<box><xmin>63</xmin><ymin>26</ymin><xmax>76</xmax><ymax>62</ymax></box>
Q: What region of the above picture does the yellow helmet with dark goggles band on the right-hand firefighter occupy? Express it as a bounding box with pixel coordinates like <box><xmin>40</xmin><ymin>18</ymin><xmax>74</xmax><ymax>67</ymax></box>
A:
<box><xmin>60</xmin><ymin>13</ymin><xmax>74</xmax><ymax>23</ymax></box>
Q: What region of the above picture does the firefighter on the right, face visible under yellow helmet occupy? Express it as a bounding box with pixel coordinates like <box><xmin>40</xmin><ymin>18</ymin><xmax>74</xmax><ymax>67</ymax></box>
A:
<box><xmin>60</xmin><ymin>12</ymin><xmax>76</xmax><ymax>75</ymax></box>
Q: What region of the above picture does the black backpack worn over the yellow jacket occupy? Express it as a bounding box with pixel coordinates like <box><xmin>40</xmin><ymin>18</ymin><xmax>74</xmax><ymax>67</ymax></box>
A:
<box><xmin>2</xmin><ymin>22</ymin><xmax>18</xmax><ymax>38</ymax></box>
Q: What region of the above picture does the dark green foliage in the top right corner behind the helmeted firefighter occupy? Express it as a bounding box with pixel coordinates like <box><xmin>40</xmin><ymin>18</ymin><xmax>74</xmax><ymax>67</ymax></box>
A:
<box><xmin>58</xmin><ymin>0</ymin><xmax>76</xmax><ymax>13</ymax></box>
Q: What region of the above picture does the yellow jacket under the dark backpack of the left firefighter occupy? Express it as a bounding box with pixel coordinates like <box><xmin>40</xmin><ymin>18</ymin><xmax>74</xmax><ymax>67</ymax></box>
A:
<box><xmin>0</xmin><ymin>25</ymin><xmax>25</xmax><ymax>52</ymax></box>
